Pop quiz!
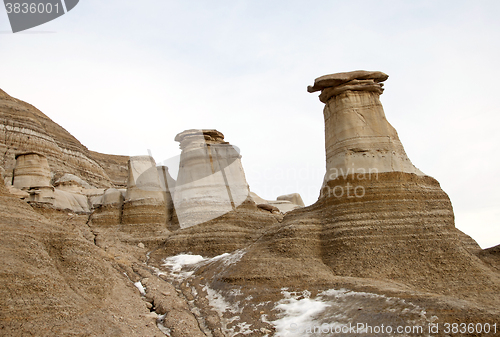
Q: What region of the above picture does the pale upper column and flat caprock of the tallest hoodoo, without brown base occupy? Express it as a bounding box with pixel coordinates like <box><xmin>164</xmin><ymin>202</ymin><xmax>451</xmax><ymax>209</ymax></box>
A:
<box><xmin>307</xmin><ymin>70</ymin><xmax>424</xmax><ymax>188</ymax></box>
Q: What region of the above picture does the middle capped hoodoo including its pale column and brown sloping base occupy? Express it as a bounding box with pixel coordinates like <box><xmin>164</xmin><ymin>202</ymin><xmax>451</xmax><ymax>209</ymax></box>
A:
<box><xmin>151</xmin><ymin>130</ymin><xmax>282</xmax><ymax>259</ymax></box>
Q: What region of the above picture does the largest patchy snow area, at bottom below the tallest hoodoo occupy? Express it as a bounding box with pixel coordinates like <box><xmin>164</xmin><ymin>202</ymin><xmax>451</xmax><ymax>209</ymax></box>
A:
<box><xmin>271</xmin><ymin>289</ymin><xmax>437</xmax><ymax>337</ymax></box>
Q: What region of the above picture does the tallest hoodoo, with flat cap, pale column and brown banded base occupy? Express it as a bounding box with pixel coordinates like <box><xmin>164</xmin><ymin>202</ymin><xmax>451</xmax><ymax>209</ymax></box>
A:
<box><xmin>302</xmin><ymin>71</ymin><xmax>498</xmax><ymax>291</ymax></box>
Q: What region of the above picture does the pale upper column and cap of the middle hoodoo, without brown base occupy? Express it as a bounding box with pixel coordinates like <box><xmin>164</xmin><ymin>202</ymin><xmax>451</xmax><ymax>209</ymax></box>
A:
<box><xmin>174</xmin><ymin>130</ymin><xmax>250</xmax><ymax>228</ymax></box>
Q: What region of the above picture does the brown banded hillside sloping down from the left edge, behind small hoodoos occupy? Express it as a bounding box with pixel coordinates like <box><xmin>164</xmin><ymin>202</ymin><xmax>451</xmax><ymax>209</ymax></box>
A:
<box><xmin>0</xmin><ymin>89</ymin><xmax>126</xmax><ymax>187</ymax></box>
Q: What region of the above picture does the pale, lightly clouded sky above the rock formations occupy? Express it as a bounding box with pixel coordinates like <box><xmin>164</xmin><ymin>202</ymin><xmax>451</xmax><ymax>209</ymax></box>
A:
<box><xmin>0</xmin><ymin>0</ymin><xmax>500</xmax><ymax>248</ymax></box>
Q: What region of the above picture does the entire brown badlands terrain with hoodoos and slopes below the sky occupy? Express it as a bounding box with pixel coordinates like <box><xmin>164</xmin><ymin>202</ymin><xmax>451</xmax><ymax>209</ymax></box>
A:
<box><xmin>0</xmin><ymin>71</ymin><xmax>500</xmax><ymax>337</ymax></box>
